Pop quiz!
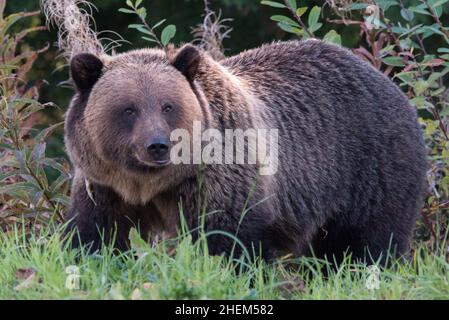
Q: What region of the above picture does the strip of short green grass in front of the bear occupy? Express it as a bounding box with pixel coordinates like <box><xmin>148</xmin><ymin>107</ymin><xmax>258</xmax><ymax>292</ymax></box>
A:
<box><xmin>0</xmin><ymin>225</ymin><xmax>449</xmax><ymax>299</ymax></box>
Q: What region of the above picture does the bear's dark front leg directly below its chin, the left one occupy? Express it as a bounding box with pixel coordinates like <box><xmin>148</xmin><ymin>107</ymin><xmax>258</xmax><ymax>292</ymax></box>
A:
<box><xmin>66</xmin><ymin>178</ymin><xmax>148</xmax><ymax>252</ymax></box>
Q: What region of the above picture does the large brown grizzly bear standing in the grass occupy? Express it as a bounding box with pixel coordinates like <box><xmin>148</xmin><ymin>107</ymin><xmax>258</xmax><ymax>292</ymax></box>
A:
<box><xmin>65</xmin><ymin>40</ymin><xmax>426</xmax><ymax>260</ymax></box>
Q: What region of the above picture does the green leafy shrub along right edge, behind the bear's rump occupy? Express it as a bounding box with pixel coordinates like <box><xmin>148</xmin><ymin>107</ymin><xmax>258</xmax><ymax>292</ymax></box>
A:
<box><xmin>261</xmin><ymin>0</ymin><xmax>449</xmax><ymax>245</ymax></box>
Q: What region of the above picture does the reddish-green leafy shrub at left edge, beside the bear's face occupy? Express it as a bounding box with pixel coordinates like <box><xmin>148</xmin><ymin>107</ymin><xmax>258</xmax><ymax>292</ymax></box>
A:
<box><xmin>0</xmin><ymin>0</ymin><xmax>69</xmax><ymax>230</ymax></box>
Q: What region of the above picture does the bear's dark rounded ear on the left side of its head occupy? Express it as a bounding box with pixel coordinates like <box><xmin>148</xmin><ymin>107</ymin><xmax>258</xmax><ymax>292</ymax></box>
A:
<box><xmin>70</xmin><ymin>53</ymin><xmax>103</xmax><ymax>92</ymax></box>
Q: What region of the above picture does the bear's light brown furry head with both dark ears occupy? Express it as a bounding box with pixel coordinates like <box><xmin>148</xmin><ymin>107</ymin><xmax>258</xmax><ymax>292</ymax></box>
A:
<box><xmin>65</xmin><ymin>45</ymin><xmax>208</xmax><ymax>201</ymax></box>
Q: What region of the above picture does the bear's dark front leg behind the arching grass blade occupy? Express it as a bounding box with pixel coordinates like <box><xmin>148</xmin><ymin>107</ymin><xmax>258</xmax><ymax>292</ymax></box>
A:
<box><xmin>181</xmin><ymin>179</ymin><xmax>280</xmax><ymax>261</ymax></box>
